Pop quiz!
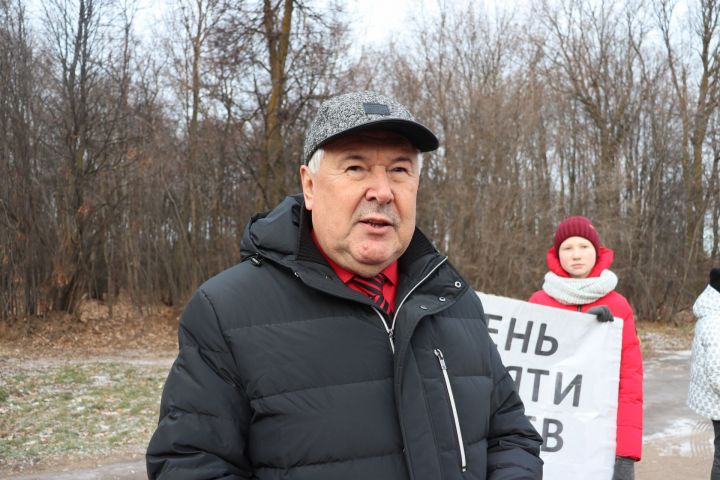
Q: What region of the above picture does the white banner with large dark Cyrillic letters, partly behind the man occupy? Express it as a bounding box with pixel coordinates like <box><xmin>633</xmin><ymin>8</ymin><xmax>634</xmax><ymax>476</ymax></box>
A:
<box><xmin>478</xmin><ymin>293</ymin><xmax>623</xmax><ymax>480</ymax></box>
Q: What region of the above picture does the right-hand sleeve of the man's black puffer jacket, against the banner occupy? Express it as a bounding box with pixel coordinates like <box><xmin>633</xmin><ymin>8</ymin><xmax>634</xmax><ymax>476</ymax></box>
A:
<box><xmin>487</xmin><ymin>348</ymin><xmax>543</xmax><ymax>480</ymax></box>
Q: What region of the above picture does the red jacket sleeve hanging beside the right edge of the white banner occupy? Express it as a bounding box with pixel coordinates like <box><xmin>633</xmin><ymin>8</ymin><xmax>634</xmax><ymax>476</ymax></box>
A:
<box><xmin>616</xmin><ymin>305</ymin><xmax>643</xmax><ymax>460</ymax></box>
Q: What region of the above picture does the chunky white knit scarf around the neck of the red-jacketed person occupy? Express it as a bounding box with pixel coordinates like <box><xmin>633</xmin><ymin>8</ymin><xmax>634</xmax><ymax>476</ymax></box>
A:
<box><xmin>543</xmin><ymin>270</ymin><xmax>617</xmax><ymax>305</ymax></box>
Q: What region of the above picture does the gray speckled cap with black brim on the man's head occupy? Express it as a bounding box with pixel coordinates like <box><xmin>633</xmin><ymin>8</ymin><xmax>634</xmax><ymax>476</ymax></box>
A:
<box><xmin>303</xmin><ymin>91</ymin><xmax>439</xmax><ymax>164</ymax></box>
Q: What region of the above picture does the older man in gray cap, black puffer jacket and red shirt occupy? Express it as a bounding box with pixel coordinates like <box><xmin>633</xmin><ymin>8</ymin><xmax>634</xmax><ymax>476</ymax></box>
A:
<box><xmin>147</xmin><ymin>92</ymin><xmax>542</xmax><ymax>480</ymax></box>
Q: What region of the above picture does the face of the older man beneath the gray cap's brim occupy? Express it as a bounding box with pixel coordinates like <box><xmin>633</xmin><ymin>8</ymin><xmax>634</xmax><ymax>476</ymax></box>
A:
<box><xmin>300</xmin><ymin>131</ymin><xmax>420</xmax><ymax>277</ymax></box>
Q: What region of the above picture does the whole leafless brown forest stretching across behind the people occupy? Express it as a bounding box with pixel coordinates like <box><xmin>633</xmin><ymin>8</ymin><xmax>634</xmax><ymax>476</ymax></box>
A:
<box><xmin>0</xmin><ymin>0</ymin><xmax>720</xmax><ymax>322</ymax></box>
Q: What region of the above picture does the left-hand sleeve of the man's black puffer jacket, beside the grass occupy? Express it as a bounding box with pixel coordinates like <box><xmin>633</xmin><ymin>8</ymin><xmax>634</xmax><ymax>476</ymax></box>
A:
<box><xmin>146</xmin><ymin>289</ymin><xmax>252</xmax><ymax>480</ymax></box>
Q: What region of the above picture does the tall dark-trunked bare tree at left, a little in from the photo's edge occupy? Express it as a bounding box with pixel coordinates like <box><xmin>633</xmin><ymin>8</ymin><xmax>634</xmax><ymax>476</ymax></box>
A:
<box><xmin>44</xmin><ymin>0</ymin><xmax>138</xmax><ymax>311</ymax></box>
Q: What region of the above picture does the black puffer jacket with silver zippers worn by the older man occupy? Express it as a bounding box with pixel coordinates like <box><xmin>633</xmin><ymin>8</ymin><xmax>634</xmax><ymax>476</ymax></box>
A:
<box><xmin>147</xmin><ymin>196</ymin><xmax>542</xmax><ymax>480</ymax></box>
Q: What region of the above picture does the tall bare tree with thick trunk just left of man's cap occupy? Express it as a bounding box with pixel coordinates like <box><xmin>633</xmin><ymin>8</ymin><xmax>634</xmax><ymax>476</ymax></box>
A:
<box><xmin>211</xmin><ymin>0</ymin><xmax>347</xmax><ymax>210</ymax></box>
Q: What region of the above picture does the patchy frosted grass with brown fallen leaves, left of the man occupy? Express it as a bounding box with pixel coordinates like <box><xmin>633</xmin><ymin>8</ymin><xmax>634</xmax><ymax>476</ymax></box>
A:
<box><xmin>0</xmin><ymin>302</ymin><xmax>178</xmax><ymax>477</ymax></box>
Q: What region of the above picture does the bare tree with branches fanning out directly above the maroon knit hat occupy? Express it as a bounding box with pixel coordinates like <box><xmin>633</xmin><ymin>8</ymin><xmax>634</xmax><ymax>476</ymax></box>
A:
<box><xmin>539</xmin><ymin>1</ymin><xmax>645</xmax><ymax>220</ymax></box>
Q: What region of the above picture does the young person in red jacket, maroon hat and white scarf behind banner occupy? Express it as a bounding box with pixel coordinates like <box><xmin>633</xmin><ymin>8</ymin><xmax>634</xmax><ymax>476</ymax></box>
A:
<box><xmin>529</xmin><ymin>216</ymin><xmax>643</xmax><ymax>480</ymax></box>
